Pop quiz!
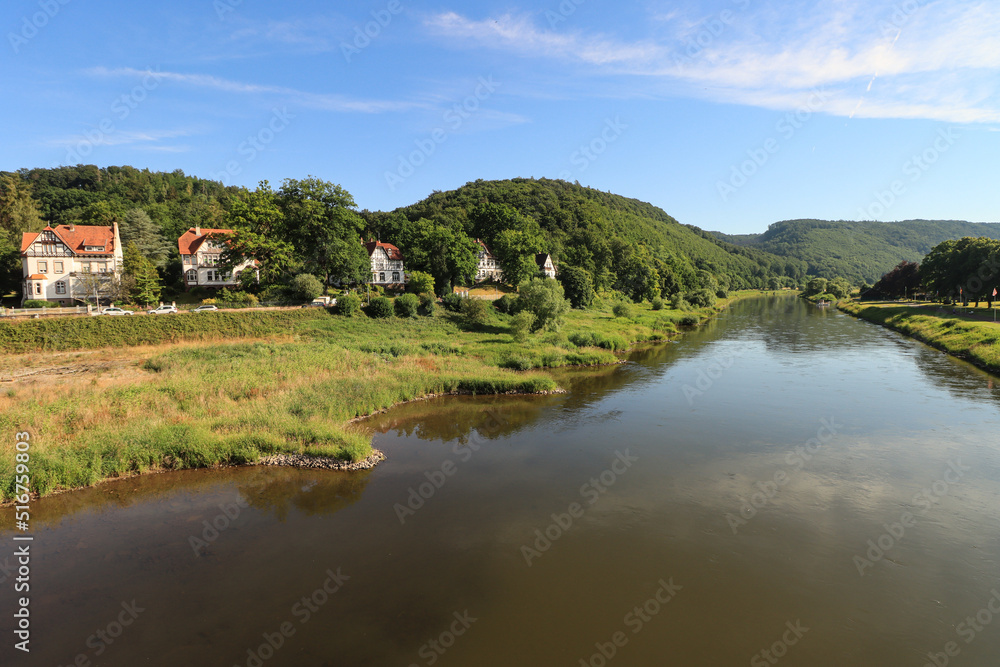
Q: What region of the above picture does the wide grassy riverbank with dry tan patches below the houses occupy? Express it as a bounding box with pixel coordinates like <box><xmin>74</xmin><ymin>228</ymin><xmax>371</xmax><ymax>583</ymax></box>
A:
<box><xmin>0</xmin><ymin>293</ymin><xmax>764</xmax><ymax>501</ymax></box>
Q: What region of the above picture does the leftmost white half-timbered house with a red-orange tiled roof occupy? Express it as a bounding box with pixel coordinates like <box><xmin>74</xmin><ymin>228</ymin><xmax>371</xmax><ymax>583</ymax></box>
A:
<box><xmin>21</xmin><ymin>222</ymin><xmax>122</xmax><ymax>306</ymax></box>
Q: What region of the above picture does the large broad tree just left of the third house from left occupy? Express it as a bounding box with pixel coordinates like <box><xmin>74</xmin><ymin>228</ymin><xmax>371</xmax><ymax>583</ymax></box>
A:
<box><xmin>278</xmin><ymin>176</ymin><xmax>371</xmax><ymax>289</ymax></box>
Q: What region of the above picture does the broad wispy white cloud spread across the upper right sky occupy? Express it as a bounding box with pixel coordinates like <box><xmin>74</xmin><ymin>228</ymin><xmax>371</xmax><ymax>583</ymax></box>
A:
<box><xmin>425</xmin><ymin>0</ymin><xmax>1000</xmax><ymax>123</ymax></box>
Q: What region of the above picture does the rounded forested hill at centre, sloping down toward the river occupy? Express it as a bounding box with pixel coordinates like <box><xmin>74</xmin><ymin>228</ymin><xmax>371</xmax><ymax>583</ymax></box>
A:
<box><xmin>378</xmin><ymin>178</ymin><xmax>805</xmax><ymax>293</ymax></box>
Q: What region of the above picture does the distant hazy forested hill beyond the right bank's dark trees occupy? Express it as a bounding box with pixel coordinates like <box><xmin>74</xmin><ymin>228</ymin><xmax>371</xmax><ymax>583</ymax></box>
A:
<box><xmin>713</xmin><ymin>220</ymin><xmax>1000</xmax><ymax>283</ymax></box>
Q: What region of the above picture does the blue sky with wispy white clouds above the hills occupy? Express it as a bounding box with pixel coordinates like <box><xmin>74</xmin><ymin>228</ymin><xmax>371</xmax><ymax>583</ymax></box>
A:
<box><xmin>0</xmin><ymin>0</ymin><xmax>1000</xmax><ymax>233</ymax></box>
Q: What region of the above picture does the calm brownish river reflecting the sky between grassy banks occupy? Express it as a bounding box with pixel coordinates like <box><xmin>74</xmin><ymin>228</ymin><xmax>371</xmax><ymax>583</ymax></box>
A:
<box><xmin>0</xmin><ymin>297</ymin><xmax>1000</xmax><ymax>667</ymax></box>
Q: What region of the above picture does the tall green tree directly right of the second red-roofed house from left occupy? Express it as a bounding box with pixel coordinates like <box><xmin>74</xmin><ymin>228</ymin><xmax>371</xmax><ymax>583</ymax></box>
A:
<box><xmin>218</xmin><ymin>181</ymin><xmax>295</xmax><ymax>282</ymax></box>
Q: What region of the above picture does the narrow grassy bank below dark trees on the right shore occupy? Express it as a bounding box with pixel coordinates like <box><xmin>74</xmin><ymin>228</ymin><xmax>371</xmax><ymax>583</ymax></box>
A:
<box><xmin>837</xmin><ymin>301</ymin><xmax>1000</xmax><ymax>373</ymax></box>
